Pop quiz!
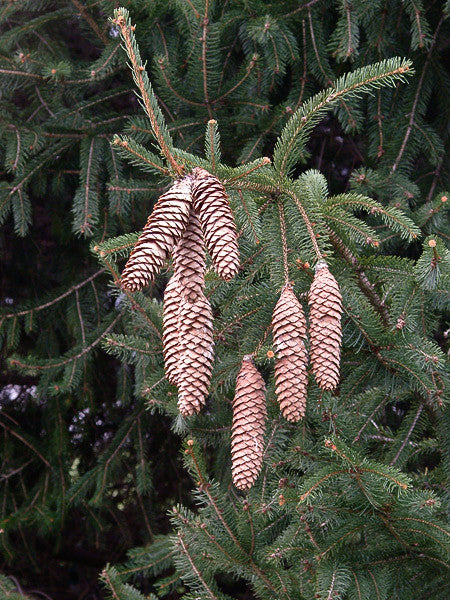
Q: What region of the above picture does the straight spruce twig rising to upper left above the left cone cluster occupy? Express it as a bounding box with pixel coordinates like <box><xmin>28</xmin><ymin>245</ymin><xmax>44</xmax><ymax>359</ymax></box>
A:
<box><xmin>114</xmin><ymin>8</ymin><xmax>183</xmax><ymax>176</ymax></box>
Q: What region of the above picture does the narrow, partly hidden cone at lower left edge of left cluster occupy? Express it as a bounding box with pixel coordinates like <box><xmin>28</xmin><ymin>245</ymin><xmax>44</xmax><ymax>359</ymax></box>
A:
<box><xmin>163</xmin><ymin>275</ymin><xmax>181</xmax><ymax>385</ymax></box>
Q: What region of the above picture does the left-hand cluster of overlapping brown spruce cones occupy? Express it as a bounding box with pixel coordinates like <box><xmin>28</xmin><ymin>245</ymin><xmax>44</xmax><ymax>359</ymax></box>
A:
<box><xmin>120</xmin><ymin>169</ymin><xmax>239</xmax><ymax>416</ymax></box>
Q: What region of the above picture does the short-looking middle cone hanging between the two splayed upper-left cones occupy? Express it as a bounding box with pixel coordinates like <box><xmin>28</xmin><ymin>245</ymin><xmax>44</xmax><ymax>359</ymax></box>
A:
<box><xmin>173</xmin><ymin>207</ymin><xmax>206</xmax><ymax>302</ymax></box>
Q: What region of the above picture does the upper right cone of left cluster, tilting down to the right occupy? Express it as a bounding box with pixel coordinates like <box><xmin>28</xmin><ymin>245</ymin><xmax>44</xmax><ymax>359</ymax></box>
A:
<box><xmin>192</xmin><ymin>167</ymin><xmax>239</xmax><ymax>281</ymax></box>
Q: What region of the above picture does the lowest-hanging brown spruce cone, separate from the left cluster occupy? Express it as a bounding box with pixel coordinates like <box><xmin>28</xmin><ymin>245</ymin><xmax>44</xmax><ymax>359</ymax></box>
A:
<box><xmin>231</xmin><ymin>356</ymin><xmax>267</xmax><ymax>490</ymax></box>
